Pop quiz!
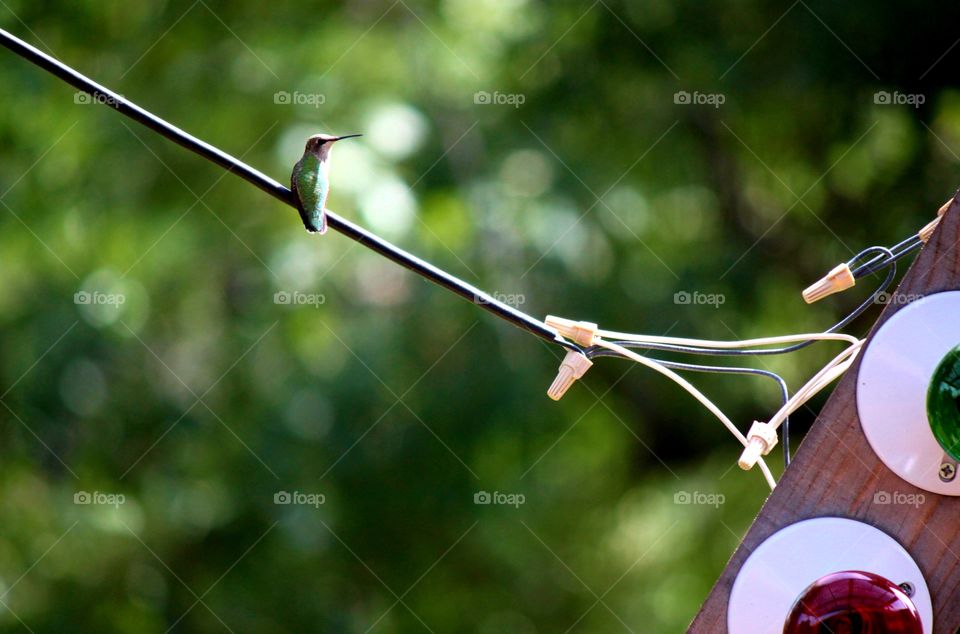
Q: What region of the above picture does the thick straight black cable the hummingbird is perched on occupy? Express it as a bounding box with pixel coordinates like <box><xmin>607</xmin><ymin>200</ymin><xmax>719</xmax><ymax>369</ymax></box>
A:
<box><xmin>0</xmin><ymin>29</ymin><xmax>581</xmax><ymax>352</ymax></box>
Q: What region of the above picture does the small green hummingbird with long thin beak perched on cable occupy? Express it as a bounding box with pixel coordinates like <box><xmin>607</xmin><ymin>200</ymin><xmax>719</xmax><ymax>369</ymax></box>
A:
<box><xmin>290</xmin><ymin>134</ymin><xmax>363</xmax><ymax>234</ymax></box>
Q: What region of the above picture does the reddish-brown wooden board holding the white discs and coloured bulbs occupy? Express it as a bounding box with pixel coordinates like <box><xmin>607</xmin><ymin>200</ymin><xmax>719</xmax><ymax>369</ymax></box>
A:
<box><xmin>687</xmin><ymin>193</ymin><xmax>960</xmax><ymax>634</ymax></box>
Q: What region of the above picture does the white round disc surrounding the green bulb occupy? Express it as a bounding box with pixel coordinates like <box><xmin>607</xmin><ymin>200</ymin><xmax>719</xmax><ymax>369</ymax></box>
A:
<box><xmin>857</xmin><ymin>291</ymin><xmax>960</xmax><ymax>495</ymax></box>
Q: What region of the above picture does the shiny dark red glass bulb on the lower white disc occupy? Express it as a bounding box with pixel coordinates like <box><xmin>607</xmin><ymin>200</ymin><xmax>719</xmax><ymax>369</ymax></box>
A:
<box><xmin>783</xmin><ymin>570</ymin><xmax>923</xmax><ymax>634</ymax></box>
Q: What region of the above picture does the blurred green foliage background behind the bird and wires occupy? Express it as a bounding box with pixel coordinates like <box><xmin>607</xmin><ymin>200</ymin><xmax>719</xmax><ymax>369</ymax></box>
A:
<box><xmin>0</xmin><ymin>0</ymin><xmax>960</xmax><ymax>634</ymax></box>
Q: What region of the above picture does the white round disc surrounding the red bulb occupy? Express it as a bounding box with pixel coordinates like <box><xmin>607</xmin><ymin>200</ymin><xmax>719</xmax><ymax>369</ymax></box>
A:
<box><xmin>727</xmin><ymin>517</ymin><xmax>933</xmax><ymax>634</ymax></box>
